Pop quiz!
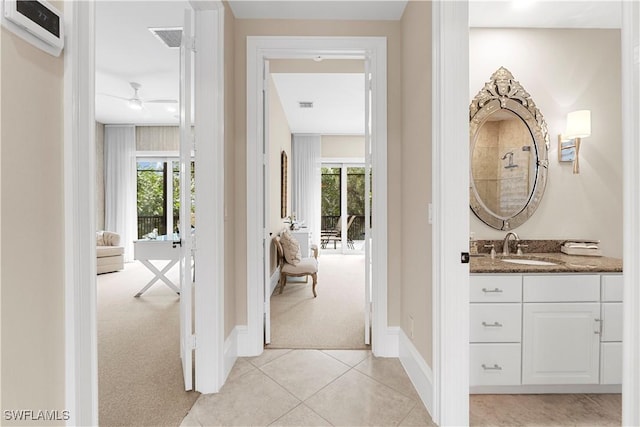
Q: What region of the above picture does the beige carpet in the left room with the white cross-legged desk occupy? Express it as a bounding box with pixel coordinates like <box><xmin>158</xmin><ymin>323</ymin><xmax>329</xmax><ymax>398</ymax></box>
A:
<box><xmin>98</xmin><ymin>262</ymin><xmax>200</xmax><ymax>426</ymax></box>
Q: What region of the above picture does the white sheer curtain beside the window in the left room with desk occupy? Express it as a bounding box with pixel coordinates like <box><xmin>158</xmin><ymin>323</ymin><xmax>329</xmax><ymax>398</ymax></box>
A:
<box><xmin>104</xmin><ymin>125</ymin><xmax>138</xmax><ymax>262</ymax></box>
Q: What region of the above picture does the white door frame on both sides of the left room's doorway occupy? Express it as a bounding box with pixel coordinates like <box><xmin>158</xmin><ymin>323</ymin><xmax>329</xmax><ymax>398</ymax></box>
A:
<box><xmin>63</xmin><ymin>0</ymin><xmax>224</xmax><ymax>425</ymax></box>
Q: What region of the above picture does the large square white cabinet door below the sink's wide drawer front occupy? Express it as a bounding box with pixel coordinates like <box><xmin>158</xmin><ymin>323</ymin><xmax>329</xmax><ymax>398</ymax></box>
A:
<box><xmin>522</xmin><ymin>303</ymin><xmax>600</xmax><ymax>384</ymax></box>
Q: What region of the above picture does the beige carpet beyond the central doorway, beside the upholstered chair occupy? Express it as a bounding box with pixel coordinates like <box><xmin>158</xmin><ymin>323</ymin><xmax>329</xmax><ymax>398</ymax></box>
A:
<box><xmin>268</xmin><ymin>253</ymin><xmax>368</xmax><ymax>349</ymax></box>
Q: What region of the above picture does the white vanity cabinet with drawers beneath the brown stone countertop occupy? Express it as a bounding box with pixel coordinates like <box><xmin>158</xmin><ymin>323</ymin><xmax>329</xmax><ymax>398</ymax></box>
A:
<box><xmin>469</xmin><ymin>274</ymin><xmax>622</xmax><ymax>393</ymax></box>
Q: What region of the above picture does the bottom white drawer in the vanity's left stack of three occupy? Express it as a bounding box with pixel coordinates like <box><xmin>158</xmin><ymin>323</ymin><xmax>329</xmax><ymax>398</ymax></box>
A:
<box><xmin>469</xmin><ymin>344</ymin><xmax>520</xmax><ymax>386</ymax></box>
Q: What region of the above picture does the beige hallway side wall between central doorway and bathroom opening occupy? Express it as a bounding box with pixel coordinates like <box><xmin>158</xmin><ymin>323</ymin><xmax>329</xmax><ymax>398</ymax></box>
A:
<box><xmin>400</xmin><ymin>1</ymin><xmax>433</xmax><ymax>366</ymax></box>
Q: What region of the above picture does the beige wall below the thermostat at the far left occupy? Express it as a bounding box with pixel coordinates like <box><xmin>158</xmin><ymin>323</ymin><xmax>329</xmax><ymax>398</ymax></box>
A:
<box><xmin>0</xmin><ymin>20</ymin><xmax>65</xmax><ymax>425</ymax></box>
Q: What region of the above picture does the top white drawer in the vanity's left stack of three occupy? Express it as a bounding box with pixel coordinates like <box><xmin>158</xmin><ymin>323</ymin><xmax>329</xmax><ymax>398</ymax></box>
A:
<box><xmin>469</xmin><ymin>274</ymin><xmax>522</xmax><ymax>302</ymax></box>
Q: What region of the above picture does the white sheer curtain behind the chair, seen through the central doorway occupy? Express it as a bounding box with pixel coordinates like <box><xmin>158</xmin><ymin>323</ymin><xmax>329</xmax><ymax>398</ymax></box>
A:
<box><xmin>291</xmin><ymin>134</ymin><xmax>321</xmax><ymax>244</ymax></box>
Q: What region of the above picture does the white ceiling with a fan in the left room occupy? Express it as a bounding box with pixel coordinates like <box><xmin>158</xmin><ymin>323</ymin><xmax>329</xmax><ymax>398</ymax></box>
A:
<box><xmin>96</xmin><ymin>1</ymin><xmax>187</xmax><ymax>124</ymax></box>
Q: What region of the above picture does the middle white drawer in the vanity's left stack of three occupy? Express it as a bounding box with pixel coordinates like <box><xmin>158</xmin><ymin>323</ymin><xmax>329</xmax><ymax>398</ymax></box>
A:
<box><xmin>469</xmin><ymin>303</ymin><xmax>522</xmax><ymax>343</ymax></box>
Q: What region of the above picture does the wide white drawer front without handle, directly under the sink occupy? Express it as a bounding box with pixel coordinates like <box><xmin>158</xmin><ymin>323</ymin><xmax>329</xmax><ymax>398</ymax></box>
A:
<box><xmin>523</xmin><ymin>274</ymin><xmax>600</xmax><ymax>302</ymax></box>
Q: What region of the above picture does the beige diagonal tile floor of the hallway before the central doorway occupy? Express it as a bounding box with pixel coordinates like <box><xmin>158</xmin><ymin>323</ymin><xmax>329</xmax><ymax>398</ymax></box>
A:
<box><xmin>181</xmin><ymin>350</ymin><xmax>435</xmax><ymax>426</ymax></box>
